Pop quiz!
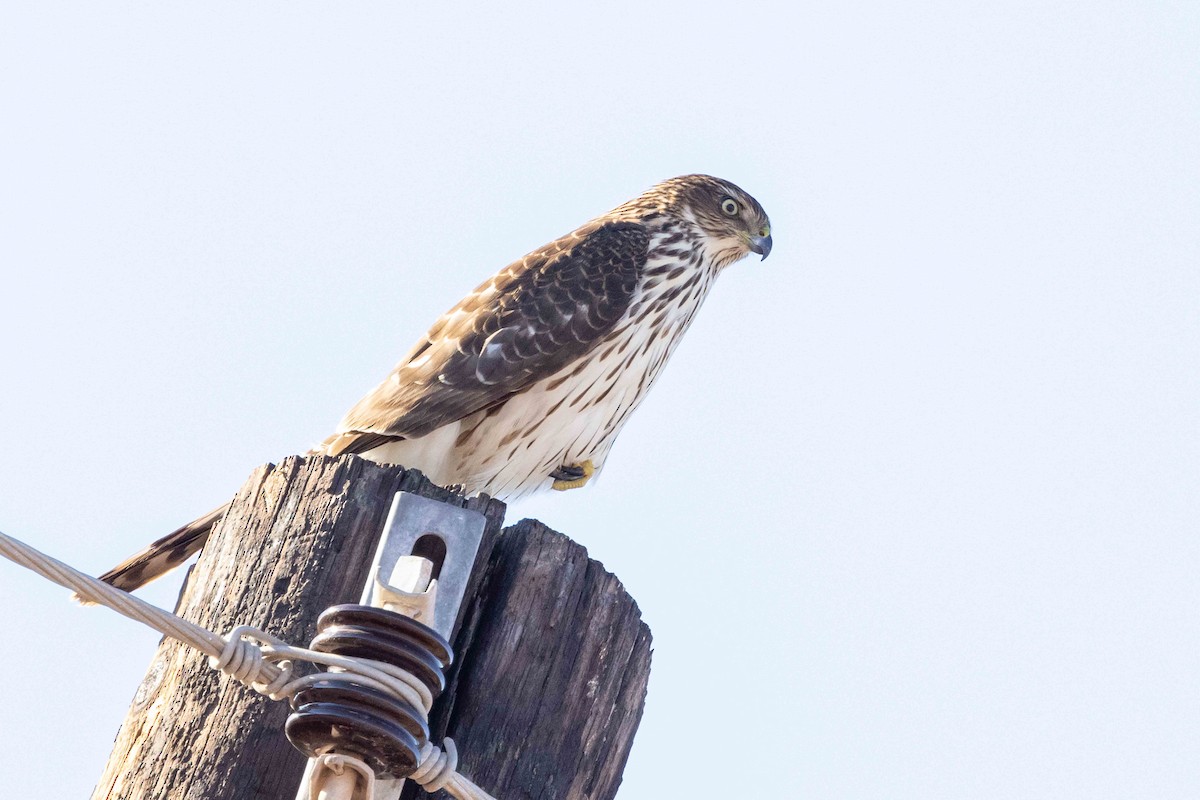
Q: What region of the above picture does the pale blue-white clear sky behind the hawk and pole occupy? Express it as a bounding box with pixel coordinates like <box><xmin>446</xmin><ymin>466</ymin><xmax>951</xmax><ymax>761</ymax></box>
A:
<box><xmin>0</xmin><ymin>2</ymin><xmax>1200</xmax><ymax>800</ymax></box>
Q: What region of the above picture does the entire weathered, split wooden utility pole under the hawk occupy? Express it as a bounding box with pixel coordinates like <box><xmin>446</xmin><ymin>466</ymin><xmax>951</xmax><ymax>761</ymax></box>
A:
<box><xmin>92</xmin><ymin>456</ymin><xmax>650</xmax><ymax>800</ymax></box>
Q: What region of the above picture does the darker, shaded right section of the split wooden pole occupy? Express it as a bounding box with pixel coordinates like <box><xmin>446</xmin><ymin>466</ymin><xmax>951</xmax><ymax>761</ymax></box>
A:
<box><xmin>415</xmin><ymin>519</ymin><xmax>650</xmax><ymax>800</ymax></box>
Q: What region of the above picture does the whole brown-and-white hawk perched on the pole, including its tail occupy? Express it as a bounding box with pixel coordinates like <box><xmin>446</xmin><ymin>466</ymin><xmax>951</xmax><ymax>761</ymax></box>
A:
<box><xmin>101</xmin><ymin>175</ymin><xmax>772</xmax><ymax>590</ymax></box>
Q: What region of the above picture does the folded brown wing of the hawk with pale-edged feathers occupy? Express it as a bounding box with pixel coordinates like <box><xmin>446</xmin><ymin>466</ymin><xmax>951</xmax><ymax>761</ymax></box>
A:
<box><xmin>329</xmin><ymin>222</ymin><xmax>649</xmax><ymax>455</ymax></box>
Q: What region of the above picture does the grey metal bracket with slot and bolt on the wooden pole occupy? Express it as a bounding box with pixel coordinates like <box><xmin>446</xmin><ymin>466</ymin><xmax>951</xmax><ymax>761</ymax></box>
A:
<box><xmin>362</xmin><ymin>492</ymin><xmax>487</xmax><ymax>639</ymax></box>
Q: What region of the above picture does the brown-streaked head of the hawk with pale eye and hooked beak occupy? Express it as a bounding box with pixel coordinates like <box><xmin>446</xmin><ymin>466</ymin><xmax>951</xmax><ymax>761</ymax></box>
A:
<box><xmin>626</xmin><ymin>175</ymin><xmax>772</xmax><ymax>267</ymax></box>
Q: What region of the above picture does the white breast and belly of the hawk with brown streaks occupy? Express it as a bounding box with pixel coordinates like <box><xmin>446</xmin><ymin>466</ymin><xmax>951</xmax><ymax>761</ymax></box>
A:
<box><xmin>364</xmin><ymin>220</ymin><xmax>718</xmax><ymax>500</ymax></box>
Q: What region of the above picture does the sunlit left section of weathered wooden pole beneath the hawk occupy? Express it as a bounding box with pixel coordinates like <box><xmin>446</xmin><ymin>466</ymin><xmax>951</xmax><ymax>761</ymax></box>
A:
<box><xmin>92</xmin><ymin>456</ymin><xmax>504</xmax><ymax>800</ymax></box>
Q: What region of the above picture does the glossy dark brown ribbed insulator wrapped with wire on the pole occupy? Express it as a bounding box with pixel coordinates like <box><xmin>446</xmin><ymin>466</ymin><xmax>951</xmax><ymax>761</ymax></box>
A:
<box><xmin>284</xmin><ymin>604</ymin><xmax>454</xmax><ymax>777</ymax></box>
